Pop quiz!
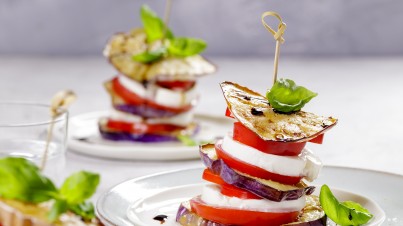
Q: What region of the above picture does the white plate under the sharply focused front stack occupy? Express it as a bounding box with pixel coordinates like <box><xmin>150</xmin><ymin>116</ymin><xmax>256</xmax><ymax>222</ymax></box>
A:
<box><xmin>96</xmin><ymin>166</ymin><xmax>403</xmax><ymax>226</ymax></box>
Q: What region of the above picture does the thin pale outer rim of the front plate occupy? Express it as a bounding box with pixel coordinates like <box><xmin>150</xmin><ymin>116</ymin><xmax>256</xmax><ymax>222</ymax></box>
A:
<box><xmin>95</xmin><ymin>165</ymin><xmax>403</xmax><ymax>225</ymax></box>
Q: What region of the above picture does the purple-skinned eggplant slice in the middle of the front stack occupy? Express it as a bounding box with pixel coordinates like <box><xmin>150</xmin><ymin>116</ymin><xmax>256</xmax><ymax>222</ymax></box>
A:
<box><xmin>200</xmin><ymin>144</ymin><xmax>315</xmax><ymax>202</ymax></box>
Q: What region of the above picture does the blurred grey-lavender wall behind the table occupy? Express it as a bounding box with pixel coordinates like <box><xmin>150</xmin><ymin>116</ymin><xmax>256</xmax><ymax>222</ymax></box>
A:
<box><xmin>0</xmin><ymin>0</ymin><xmax>403</xmax><ymax>56</ymax></box>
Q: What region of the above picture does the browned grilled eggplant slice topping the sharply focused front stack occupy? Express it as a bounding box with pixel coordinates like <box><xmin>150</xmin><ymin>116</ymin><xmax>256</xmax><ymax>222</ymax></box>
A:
<box><xmin>220</xmin><ymin>82</ymin><xmax>337</xmax><ymax>142</ymax></box>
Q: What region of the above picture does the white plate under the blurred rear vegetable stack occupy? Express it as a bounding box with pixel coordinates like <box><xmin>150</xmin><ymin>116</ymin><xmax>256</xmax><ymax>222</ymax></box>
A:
<box><xmin>64</xmin><ymin>111</ymin><xmax>233</xmax><ymax>160</ymax></box>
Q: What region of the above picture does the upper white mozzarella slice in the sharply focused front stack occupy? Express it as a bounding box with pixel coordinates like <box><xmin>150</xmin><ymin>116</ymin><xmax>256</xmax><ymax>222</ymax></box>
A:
<box><xmin>222</xmin><ymin>135</ymin><xmax>322</xmax><ymax>181</ymax></box>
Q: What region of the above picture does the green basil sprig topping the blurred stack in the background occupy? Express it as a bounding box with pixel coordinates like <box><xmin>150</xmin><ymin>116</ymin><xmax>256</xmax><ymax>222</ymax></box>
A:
<box><xmin>132</xmin><ymin>5</ymin><xmax>207</xmax><ymax>63</ymax></box>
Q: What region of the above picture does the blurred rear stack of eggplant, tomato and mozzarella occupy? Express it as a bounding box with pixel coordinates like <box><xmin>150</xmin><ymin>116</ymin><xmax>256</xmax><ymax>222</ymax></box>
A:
<box><xmin>99</xmin><ymin>29</ymin><xmax>215</xmax><ymax>142</ymax></box>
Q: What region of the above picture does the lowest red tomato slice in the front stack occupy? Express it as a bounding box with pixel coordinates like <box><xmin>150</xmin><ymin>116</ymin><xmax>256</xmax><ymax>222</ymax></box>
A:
<box><xmin>190</xmin><ymin>196</ymin><xmax>299</xmax><ymax>226</ymax></box>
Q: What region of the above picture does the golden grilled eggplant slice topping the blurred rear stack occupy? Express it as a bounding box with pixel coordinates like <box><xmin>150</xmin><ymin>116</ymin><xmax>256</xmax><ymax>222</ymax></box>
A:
<box><xmin>104</xmin><ymin>29</ymin><xmax>216</xmax><ymax>82</ymax></box>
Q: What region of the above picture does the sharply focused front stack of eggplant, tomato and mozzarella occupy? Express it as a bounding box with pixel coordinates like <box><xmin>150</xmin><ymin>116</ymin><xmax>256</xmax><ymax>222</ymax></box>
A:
<box><xmin>176</xmin><ymin>82</ymin><xmax>337</xmax><ymax>226</ymax></box>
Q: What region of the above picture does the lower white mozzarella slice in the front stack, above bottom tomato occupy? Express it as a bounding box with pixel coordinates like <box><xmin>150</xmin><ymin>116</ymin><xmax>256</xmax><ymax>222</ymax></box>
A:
<box><xmin>201</xmin><ymin>184</ymin><xmax>306</xmax><ymax>213</ymax></box>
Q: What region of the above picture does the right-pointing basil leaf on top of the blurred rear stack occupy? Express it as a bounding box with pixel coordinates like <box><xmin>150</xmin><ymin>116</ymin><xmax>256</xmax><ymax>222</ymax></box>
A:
<box><xmin>168</xmin><ymin>37</ymin><xmax>207</xmax><ymax>57</ymax></box>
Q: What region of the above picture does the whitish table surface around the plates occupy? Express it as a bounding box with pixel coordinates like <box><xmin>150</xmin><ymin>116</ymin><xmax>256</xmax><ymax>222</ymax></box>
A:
<box><xmin>0</xmin><ymin>56</ymin><xmax>403</xmax><ymax>199</ymax></box>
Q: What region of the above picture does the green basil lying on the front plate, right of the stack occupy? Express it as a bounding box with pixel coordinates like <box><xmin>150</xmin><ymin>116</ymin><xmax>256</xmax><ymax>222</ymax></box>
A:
<box><xmin>319</xmin><ymin>184</ymin><xmax>373</xmax><ymax>225</ymax></box>
